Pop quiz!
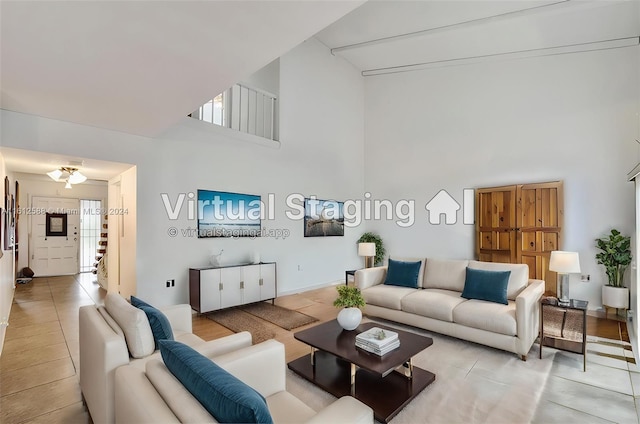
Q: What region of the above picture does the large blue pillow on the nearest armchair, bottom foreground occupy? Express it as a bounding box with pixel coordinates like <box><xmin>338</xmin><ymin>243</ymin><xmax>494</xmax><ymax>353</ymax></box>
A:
<box><xmin>160</xmin><ymin>340</ymin><xmax>273</xmax><ymax>423</ymax></box>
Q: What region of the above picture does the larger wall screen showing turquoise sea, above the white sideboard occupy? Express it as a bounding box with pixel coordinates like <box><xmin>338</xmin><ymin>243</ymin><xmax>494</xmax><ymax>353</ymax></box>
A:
<box><xmin>198</xmin><ymin>190</ymin><xmax>262</xmax><ymax>238</ymax></box>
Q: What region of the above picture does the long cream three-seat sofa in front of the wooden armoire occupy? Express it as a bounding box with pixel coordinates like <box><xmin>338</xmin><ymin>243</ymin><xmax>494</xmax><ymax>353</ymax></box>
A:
<box><xmin>355</xmin><ymin>258</ymin><xmax>544</xmax><ymax>360</ymax></box>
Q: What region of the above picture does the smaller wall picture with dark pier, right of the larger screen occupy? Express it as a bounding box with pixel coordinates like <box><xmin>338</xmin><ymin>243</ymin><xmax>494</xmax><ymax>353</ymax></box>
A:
<box><xmin>304</xmin><ymin>198</ymin><xmax>344</xmax><ymax>237</ymax></box>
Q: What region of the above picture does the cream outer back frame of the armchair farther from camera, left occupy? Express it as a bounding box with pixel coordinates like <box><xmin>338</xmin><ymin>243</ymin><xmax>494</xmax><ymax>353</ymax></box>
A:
<box><xmin>78</xmin><ymin>305</ymin><xmax>129</xmax><ymax>424</ymax></box>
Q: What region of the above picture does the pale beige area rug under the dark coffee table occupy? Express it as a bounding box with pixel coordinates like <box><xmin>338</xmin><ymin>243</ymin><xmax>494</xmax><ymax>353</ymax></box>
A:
<box><xmin>287</xmin><ymin>321</ymin><xmax>552</xmax><ymax>424</ymax></box>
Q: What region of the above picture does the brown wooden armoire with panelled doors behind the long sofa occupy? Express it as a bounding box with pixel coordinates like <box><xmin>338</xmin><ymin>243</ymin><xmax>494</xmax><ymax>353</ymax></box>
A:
<box><xmin>476</xmin><ymin>181</ymin><xmax>564</xmax><ymax>293</ymax></box>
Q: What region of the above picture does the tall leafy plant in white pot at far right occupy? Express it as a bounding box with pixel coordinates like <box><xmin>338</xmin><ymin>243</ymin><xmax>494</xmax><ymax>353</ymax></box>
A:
<box><xmin>596</xmin><ymin>228</ymin><xmax>632</xmax><ymax>309</ymax></box>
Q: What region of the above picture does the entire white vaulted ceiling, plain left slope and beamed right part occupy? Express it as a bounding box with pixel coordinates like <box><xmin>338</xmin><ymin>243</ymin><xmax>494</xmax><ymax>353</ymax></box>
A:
<box><xmin>0</xmin><ymin>0</ymin><xmax>640</xmax><ymax>141</ymax></box>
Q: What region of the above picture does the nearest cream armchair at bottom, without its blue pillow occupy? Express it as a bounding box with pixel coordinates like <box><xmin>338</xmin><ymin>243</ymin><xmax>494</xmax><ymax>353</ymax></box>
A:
<box><xmin>115</xmin><ymin>340</ymin><xmax>373</xmax><ymax>424</ymax></box>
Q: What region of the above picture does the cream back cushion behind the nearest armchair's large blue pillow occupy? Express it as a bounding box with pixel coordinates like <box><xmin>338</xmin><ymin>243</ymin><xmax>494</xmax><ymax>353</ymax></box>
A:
<box><xmin>145</xmin><ymin>359</ymin><xmax>217</xmax><ymax>423</ymax></box>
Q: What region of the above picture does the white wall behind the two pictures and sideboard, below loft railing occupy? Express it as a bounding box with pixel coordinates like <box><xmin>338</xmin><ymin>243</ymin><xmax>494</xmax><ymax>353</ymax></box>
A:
<box><xmin>0</xmin><ymin>39</ymin><xmax>364</xmax><ymax>305</ymax></box>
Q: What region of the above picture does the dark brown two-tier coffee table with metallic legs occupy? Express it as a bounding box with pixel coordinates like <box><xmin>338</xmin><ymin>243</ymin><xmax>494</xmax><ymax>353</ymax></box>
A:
<box><xmin>288</xmin><ymin>320</ymin><xmax>436</xmax><ymax>422</ymax></box>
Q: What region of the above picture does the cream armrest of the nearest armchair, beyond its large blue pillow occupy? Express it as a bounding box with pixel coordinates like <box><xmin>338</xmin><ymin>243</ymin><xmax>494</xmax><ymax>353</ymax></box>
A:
<box><xmin>212</xmin><ymin>339</ymin><xmax>287</xmax><ymax>398</ymax></box>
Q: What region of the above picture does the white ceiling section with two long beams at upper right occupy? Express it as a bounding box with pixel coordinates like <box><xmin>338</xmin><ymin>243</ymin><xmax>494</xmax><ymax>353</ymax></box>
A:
<box><xmin>316</xmin><ymin>0</ymin><xmax>640</xmax><ymax>76</ymax></box>
